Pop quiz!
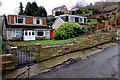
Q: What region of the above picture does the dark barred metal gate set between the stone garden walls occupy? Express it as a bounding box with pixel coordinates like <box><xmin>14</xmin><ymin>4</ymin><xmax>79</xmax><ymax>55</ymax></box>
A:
<box><xmin>17</xmin><ymin>49</ymin><xmax>35</xmax><ymax>65</ymax></box>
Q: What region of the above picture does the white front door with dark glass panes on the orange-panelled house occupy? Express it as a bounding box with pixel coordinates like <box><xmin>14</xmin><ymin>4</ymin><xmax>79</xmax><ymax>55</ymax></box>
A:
<box><xmin>23</xmin><ymin>30</ymin><xmax>35</xmax><ymax>41</ymax></box>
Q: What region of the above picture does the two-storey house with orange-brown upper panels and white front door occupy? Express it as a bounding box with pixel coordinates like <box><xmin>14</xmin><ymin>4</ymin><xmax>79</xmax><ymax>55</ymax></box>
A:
<box><xmin>2</xmin><ymin>15</ymin><xmax>50</xmax><ymax>41</ymax></box>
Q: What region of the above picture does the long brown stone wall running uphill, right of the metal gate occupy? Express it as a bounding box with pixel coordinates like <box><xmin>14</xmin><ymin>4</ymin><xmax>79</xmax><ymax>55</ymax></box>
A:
<box><xmin>21</xmin><ymin>33</ymin><xmax>116</xmax><ymax>62</ymax></box>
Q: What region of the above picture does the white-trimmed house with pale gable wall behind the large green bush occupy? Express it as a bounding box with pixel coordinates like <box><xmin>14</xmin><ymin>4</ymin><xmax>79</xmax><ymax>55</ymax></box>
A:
<box><xmin>52</xmin><ymin>14</ymin><xmax>87</xmax><ymax>29</ymax></box>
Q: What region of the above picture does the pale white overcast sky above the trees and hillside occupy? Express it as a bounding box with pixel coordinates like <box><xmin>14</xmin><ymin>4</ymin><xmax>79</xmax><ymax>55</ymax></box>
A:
<box><xmin>0</xmin><ymin>0</ymin><xmax>96</xmax><ymax>15</ymax></box>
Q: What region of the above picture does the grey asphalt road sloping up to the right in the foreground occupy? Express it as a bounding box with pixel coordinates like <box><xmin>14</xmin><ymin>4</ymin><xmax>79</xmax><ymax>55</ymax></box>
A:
<box><xmin>32</xmin><ymin>44</ymin><xmax>120</xmax><ymax>78</ymax></box>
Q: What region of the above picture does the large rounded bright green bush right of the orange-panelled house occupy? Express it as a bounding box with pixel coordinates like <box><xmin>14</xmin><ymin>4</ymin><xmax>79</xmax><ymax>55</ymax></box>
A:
<box><xmin>53</xmin><ymin>22</ymin><xmax>84</xmax><ymax>40</ymax></box>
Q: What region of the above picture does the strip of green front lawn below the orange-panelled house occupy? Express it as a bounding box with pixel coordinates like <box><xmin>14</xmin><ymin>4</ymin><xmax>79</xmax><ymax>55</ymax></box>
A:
<box><xmin>7</xmin><ymin>39</ymin><xmax>71</xmax><ymax>46</ymax></box>
